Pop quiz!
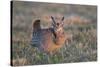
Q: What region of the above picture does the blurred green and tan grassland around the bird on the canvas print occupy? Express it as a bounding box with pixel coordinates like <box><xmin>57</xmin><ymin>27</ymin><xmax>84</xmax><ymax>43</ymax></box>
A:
<box><xmin>11</xmin><ymin>1</ymin><xmax>97</xmax><ymax>65</ymax></box>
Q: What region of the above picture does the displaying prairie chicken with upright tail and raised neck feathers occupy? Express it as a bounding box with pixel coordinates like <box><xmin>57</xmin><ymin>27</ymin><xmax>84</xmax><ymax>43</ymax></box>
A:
<box><xmin>32</xmin><ymin>16</ymin><xmax>66</xmax><ymax>53</ymax></box>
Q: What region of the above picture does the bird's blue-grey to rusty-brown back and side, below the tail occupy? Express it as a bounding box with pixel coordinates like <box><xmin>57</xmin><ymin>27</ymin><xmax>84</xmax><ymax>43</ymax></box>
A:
<box><xmin>32</xmin><ymin>28</ymin><xmax>54</xmax><ymax>51</ymax></box>
